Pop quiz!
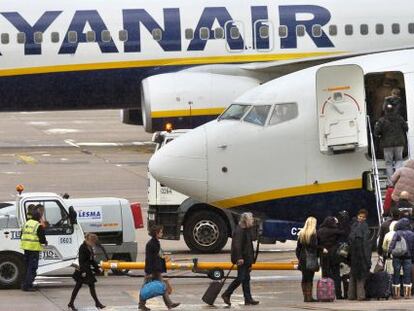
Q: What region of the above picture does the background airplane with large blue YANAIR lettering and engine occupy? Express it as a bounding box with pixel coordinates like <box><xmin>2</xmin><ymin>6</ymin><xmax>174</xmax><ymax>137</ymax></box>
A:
<box><xmin>0</xmin><ymin>0</ymin><xmax>414</xmax><ymax>132</ymax></box>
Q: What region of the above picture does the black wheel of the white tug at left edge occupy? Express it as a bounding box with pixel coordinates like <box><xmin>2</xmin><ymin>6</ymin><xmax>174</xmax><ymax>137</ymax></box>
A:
<box><xmin>0</xmin><ymin>254</ymin><xmax>26</xmax><ymax>289</ymax></box>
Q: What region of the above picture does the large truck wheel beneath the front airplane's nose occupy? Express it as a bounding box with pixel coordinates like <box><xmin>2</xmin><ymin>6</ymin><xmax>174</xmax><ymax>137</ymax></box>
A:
<box><xmin>184</xmin><ymin>211</ymin><xmax>228</xmax><ymax>253</ymax></box>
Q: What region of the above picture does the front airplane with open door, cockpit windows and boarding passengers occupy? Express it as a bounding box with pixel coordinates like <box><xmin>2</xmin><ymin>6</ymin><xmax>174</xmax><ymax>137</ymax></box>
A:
<box><xmin>149</xmin><ymin>49</ymin><xmax>414</xmax><ymax>241</ymax></box>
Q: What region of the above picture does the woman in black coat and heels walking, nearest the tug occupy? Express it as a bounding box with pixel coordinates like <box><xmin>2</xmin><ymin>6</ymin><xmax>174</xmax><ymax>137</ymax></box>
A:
<box><xmin>68</xmin><ymin>233</ymin><xmax>105</xmax><ymax>311</ymax></box>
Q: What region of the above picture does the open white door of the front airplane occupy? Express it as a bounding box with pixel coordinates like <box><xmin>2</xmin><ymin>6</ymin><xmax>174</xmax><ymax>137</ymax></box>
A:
<box><xmin>316</xmin><ymin>65</ymin><xmax>368</xmax><ymax>154</ymax></box>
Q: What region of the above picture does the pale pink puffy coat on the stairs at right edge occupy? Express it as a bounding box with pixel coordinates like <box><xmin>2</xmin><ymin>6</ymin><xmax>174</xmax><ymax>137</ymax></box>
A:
<box><xmin>391</xmin><ymin>160</ymin><xmax>414</xmax><ymax>203</ymax></box>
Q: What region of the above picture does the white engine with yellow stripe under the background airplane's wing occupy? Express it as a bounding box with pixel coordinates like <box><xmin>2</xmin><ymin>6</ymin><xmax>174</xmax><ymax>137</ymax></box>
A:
<box><xmin>141</xmin><ymin>72</ymin><xmax>260</xmax><ymax>132</ymax></box>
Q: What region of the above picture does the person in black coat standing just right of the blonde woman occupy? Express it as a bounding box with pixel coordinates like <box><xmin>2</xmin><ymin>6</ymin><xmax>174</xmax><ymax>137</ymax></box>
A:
<box><xmin>317</xmin><ymin>216</ymin><xmax>344</xmax><ymax>299</ymax></box>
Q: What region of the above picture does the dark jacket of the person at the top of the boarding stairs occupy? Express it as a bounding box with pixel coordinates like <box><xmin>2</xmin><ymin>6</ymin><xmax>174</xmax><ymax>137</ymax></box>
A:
<box><xmin>374</xmin><ymin>112</ymin><xmax>408</xmax><ymax>148</ymax></box>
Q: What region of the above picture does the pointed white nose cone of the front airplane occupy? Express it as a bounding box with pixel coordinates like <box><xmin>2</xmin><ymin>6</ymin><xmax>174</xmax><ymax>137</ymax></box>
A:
<box><xmin>148</xmin><ymin>127</ymin><xmax>207</xmax><ymax>202</ymax></box>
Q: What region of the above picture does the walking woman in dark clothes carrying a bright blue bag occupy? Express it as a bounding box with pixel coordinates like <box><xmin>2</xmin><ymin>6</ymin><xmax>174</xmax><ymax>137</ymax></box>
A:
<box><xmin>138</xmin><ymin>225</ymin><xmax>180</xmax><ymax>311</ymax></box>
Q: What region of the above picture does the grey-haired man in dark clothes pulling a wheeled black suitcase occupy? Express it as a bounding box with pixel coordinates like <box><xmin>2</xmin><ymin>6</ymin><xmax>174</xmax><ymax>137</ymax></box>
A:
<box><xmin>221</xmin><ymin>213</ymin><xmax>259</xmax><ymax>306</ymax></box>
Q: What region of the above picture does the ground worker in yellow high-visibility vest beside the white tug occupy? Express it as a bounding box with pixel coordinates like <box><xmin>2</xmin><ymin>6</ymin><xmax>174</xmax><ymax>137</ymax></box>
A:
<box><xmin>20</xmin><ymin>211</ymin><xmax>47</xmax><ymax>291</ymax></box>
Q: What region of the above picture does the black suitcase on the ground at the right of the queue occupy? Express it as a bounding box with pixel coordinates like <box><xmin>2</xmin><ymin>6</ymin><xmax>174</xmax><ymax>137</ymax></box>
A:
<box><xmin>365</xmin><ymin>271</ymin><xmax>392</xmax><ymax>299</ymax></box>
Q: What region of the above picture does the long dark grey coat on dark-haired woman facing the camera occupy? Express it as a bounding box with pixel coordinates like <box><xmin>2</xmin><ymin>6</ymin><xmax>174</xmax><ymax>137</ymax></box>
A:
<box><xmin>349</xmin><ymin>222</ymin><xmax>372</xmax><ymax>280</ymax></box>
